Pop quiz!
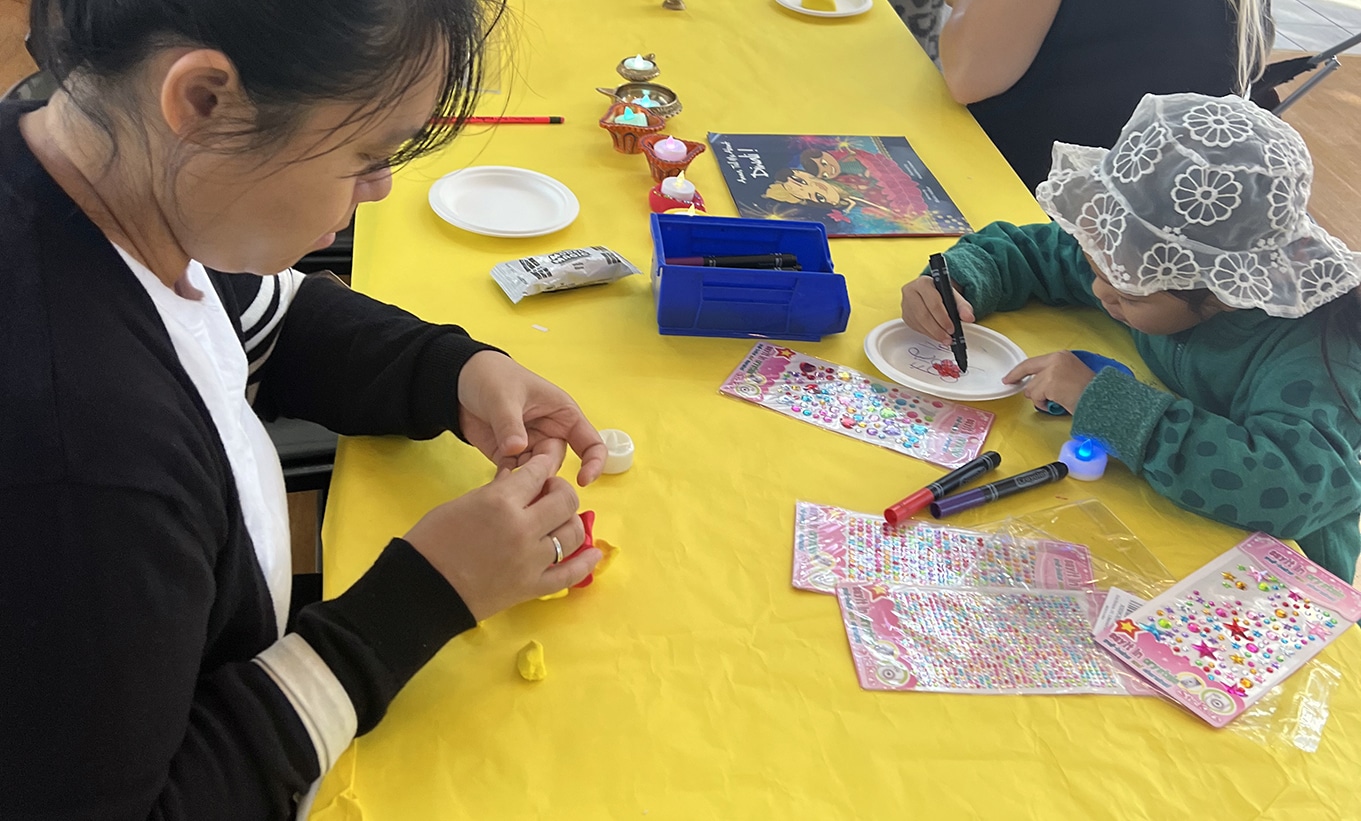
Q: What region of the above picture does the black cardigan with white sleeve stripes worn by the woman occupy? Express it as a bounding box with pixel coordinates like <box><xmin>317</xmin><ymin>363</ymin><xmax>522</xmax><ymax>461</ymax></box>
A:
<box><xmin>0</xmin><ymin>103</ymin><xmax>487</xmax><ymax>820</ymax></box>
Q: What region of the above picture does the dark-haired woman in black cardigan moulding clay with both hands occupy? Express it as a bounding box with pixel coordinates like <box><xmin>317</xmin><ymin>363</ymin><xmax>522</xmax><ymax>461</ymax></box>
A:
<box><xmin>0</xmin><ymin>0</ymin><xmax>604</xmax><ymax>820</ymax></box>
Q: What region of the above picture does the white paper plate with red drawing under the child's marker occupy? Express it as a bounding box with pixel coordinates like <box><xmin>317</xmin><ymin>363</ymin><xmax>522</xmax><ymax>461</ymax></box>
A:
<box><xmin>864</xmin><ymin>320</ymin><xmax>1026</xmax><ymax>402</ymax></box>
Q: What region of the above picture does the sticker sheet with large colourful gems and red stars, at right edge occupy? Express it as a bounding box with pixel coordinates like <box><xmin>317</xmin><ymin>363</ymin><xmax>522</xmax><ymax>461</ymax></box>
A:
<box><xmin>1097</xmin><ymin>534</ymin><xmax>1361</xmax><ymax>727</ymax></box>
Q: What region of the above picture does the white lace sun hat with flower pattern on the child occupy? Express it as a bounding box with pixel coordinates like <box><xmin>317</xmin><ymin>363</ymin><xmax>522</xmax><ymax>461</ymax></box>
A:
<box><xmin>1034</xmin><ymin>94</ymin><xmax>1361</xmax><ymax>317</ymax></box>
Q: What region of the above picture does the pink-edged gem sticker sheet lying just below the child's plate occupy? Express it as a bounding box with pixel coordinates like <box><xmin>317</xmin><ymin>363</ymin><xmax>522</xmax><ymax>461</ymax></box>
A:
<box><xmin>719</xmin><ymin>342</ymin><xmax>994</xmax><ymax>467</ymax></box>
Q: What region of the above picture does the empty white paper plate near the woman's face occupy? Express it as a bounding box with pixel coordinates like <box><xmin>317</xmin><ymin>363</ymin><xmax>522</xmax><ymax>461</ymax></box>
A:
<box><xmin>430</xmin><ymin>165</ymin><xmax>581</xmax><ymax>237</ymax></box>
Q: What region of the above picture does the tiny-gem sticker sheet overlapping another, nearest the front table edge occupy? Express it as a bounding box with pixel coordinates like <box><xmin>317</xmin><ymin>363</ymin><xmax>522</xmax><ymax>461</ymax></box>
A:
<box><xmin>837</xmin><ymin>584</ymin><xmax>1127</xmax><ymax>696</ymax></box>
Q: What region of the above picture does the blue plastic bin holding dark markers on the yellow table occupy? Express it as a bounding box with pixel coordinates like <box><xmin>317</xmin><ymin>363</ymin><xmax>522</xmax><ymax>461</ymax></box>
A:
<box><xmin>652</xmin><ymin>214</ymin><xmax>851</xmax><ymax>342</ymax></box>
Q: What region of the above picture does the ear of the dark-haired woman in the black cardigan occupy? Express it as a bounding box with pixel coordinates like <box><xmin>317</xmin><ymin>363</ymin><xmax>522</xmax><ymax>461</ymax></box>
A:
<box><xmin>161</xmin><ymin>49</ymin><xmax>245</xmax><ymax>142</ymax></box>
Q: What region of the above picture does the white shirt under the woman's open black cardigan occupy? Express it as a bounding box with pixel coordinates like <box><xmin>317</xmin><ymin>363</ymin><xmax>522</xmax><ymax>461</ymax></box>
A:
<box><xmin>114</xmin><ymin>245</ymin><xmax>293</xmax><ymax>636</ymax></box>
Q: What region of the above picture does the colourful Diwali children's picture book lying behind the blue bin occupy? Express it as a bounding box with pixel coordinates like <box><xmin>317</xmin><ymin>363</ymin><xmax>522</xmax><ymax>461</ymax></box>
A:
<box><xmin>709</xmin><ymin>132</ymin><xmax>973</xmax><ymax>237</ymax></box>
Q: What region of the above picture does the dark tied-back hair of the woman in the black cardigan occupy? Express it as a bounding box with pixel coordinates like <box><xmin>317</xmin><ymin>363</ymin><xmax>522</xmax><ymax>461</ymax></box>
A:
<box><xmin>30</xmin><ymin>0</ymin><xmax>505</xmax><ymax>165</ymax></box>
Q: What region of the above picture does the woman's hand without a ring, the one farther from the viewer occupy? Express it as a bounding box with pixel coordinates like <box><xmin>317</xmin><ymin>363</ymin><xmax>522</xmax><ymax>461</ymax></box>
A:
<box><xmin>459</xmin><ymin>351</ymin><xmax>606</xmax><ymax>487</ymax></box>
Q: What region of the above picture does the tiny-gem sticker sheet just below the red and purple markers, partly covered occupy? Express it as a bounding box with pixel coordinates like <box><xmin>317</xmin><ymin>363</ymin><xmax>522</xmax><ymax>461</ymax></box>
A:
<box><xmin>793</xmin><ymin>501</ymin><xmax>1094</xmax><ymax>594</ymax></box>
